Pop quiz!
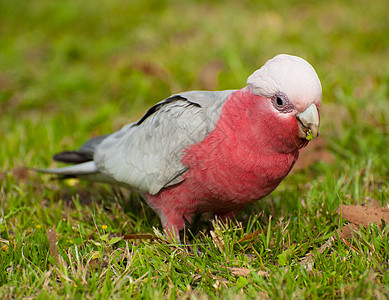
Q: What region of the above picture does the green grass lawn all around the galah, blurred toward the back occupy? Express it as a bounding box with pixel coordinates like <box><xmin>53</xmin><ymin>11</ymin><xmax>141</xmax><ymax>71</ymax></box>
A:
<box><xmin>0</xmin><ymin>0</ymin><xmax>389</xmax><ymax>299</ymax></box>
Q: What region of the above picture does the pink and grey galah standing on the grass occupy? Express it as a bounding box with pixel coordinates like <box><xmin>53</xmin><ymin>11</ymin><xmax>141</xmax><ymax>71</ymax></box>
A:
<box><xmin>38</xmin><ymin>54</ymin><xmax>322</xmax><ymax>237</ymax></box>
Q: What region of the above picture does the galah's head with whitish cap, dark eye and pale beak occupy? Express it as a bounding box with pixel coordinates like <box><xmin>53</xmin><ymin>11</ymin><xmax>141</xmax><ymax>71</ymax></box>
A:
<box><xmin>247</xmin><ymin>54</ymin><xmax>322</xmax><ymax>144</ymax></box>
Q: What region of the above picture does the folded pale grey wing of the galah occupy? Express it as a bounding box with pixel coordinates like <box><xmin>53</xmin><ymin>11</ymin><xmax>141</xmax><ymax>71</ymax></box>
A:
<box><xmin>94</xmin><ymin>90</ymin><xmax>233</xmax><ymax>194</ymax></box>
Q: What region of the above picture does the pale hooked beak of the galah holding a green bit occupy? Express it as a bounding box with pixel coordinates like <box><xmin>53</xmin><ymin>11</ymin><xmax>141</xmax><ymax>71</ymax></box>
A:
<box><xmin>296</xmin><ymin>103</ymin><xmax>320</xmax><ymax>141</ymax></box>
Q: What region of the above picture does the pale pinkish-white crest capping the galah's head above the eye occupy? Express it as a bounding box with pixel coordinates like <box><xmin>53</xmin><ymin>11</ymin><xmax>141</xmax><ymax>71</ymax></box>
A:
<box><xmin>247</xmin><ymin>54</ymin><xmax>322</xmax><ymax>111</ymax></box>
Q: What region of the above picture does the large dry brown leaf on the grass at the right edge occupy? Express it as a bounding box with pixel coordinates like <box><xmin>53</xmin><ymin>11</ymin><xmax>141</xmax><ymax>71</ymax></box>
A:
<box><xmin>337</xmin><ymin>204</ymin><xmax>389</xmax><ymax>227</ymax></box>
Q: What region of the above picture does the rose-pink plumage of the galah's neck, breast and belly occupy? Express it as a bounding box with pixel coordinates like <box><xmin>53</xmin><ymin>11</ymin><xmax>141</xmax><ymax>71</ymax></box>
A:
<box><xmin>149</xmin><ymin>89</ymin><xmax>300</xmax><ymax>220</ymax></box>
